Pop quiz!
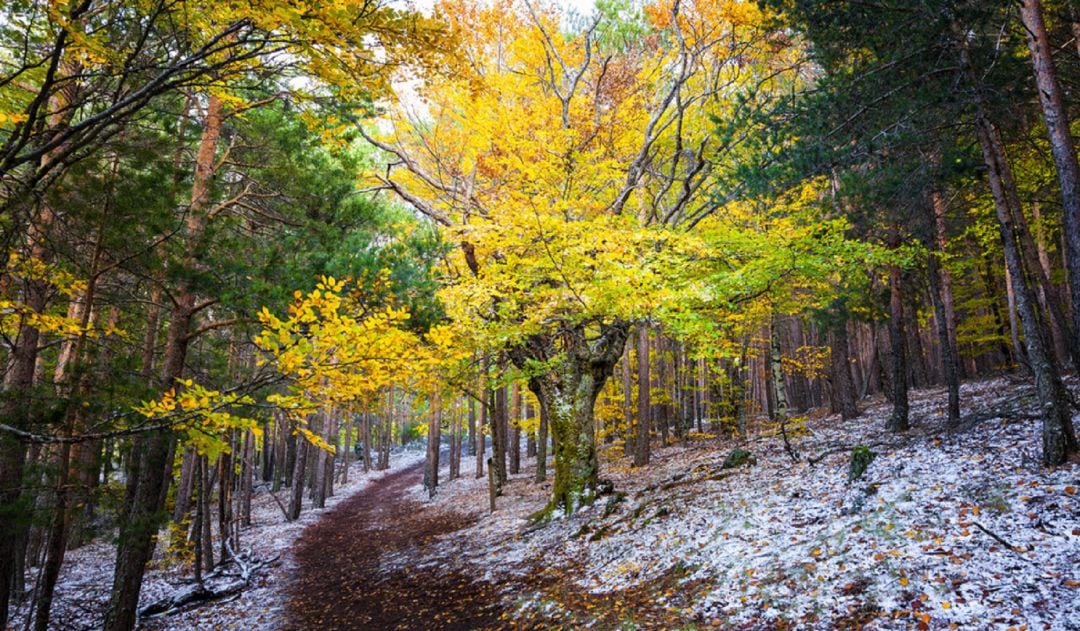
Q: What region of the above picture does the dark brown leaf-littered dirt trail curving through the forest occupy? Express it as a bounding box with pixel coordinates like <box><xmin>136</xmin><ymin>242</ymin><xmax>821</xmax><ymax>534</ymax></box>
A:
<box><xmin>284</xmin><ymin>464</ymin><xmax>501</xmax><ymax>630</ymax></box>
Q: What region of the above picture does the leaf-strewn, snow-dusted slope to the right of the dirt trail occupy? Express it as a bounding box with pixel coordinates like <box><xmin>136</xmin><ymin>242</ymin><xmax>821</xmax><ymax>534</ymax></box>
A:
<box><xmin>418</xmin><ymin>378</ymin><xmax>1080</xmax><ymax>630</ymax></box>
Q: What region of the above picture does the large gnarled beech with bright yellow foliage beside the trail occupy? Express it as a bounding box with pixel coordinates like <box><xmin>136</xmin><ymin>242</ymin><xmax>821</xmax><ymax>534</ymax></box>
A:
<box><xmin>368</xmin><ymin>2</ymin><xmax>855</xmax><ymax>516</ymax></box>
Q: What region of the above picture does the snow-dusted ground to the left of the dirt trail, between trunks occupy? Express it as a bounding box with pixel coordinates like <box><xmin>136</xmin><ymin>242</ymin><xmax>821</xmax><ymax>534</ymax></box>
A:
<box><xmin>12</xmin><ymin>446</ymin><xmax>424</xmax><ymax>631</ymax></box>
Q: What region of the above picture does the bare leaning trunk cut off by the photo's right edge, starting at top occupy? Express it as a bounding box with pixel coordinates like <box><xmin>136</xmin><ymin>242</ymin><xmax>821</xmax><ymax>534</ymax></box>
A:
<box><xmin>1020</xmin><ymin>0</ymin><xmax>1080</xmax><ymax>368</ymax></box>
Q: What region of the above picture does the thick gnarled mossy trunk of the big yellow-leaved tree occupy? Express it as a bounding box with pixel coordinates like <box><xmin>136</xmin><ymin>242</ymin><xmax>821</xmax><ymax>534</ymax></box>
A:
<box><xmin>510</xmin><ymin>321</ymin><xmax>630</xmax><ymax>519</ymax></box>
